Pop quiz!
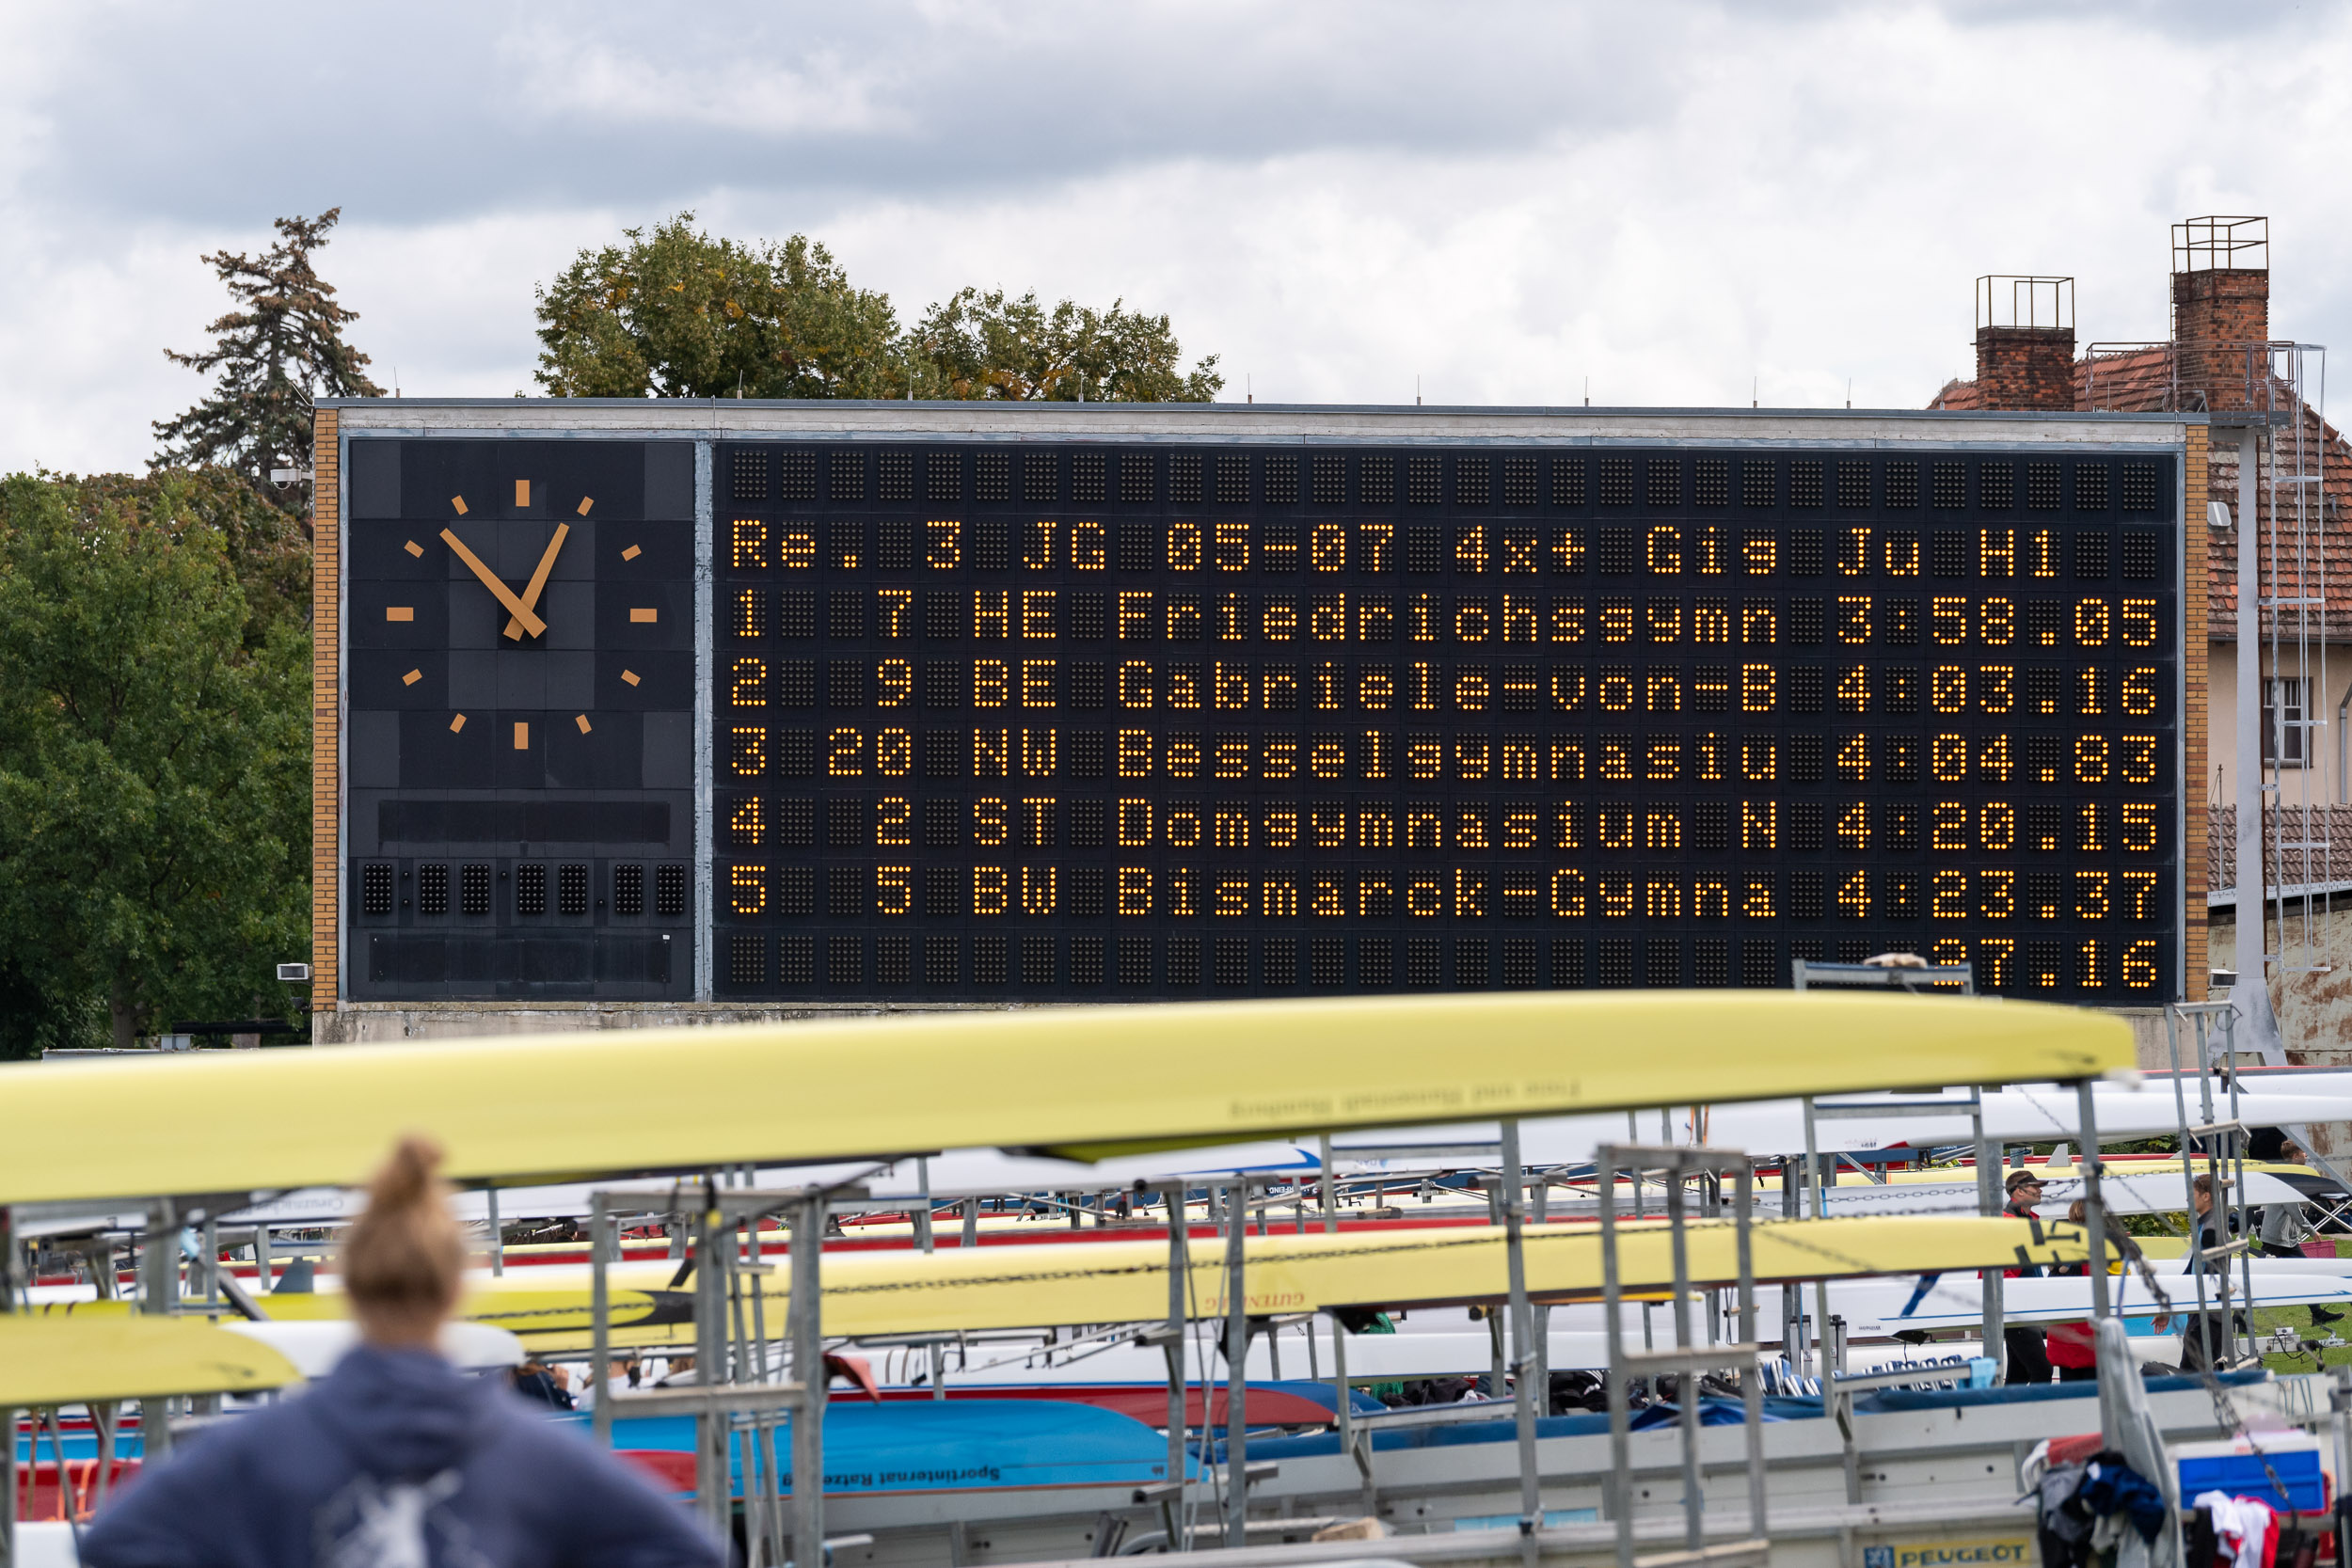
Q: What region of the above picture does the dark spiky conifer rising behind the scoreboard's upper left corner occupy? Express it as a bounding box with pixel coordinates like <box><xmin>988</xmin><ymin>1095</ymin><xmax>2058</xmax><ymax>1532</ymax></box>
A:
<box><xmin>155</xmin><ymin>207</ymin><xmax>384</xmax><ymax>515</ymax></box>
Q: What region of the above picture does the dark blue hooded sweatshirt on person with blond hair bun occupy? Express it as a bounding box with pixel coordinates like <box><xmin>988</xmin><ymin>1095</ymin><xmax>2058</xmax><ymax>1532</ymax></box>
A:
<box><xmin>83</xmin><ymin>1345</ymin><xmax>724</xmax><ymax>1568</ymax></box>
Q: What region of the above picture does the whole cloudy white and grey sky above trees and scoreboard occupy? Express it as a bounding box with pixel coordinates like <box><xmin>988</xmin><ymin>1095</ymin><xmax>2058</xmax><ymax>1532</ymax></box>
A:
<box><xmin>0</xmin><ymin>0</ymin><xmax>2352</xmax><ymax>470</ymax></box>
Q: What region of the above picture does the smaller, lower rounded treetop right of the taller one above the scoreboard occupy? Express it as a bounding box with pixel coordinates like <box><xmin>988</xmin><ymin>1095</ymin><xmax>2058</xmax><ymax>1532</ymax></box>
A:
<box><xmin>913</xmin><ymin>289</ymin><xmax>1226</xmax><ymax>402</ymax></box>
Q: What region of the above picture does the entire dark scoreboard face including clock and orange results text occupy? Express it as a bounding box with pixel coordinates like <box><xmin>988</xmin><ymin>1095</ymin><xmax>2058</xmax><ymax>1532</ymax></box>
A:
<box><xmin>331</xmin><ymin>420</ymin><xmax>2183</xmax><ymax>1004</ymax></box>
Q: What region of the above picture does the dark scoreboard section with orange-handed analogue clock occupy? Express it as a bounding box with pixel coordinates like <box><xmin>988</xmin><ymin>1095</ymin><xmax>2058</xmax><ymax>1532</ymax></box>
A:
<box><xmin>343</xmin><ymin>437</ymin><xmax>694</xmax><ymax>1002</ymax></box>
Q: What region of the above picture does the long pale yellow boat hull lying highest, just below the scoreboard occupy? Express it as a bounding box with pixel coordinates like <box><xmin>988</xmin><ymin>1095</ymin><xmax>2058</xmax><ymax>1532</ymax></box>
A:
<box><xmin>0</xmin><ymin>992</ymin><xmax>2134</xmax><ymax>1204</ymax></box>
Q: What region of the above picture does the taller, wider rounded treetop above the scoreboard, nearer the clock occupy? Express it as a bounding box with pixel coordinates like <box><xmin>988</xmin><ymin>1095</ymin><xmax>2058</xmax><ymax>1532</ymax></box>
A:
<box><xmin>534</xmin><ymin>212</ymin><xmax>906</xmax><ymax>397</ymax></box>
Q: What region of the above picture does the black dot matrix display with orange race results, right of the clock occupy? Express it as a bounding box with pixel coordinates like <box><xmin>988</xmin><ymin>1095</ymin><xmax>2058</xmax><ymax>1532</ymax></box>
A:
<box><xmin>708</xmin><ymin>439</ymin><xmax>2181</xmax><ymax>1004</ymax></box>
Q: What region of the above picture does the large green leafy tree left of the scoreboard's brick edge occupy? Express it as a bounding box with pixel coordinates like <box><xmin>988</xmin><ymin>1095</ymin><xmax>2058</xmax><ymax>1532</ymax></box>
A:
<box><xmin>0</xmin><ymin>475</ymin><xmax>310</xmax><ymax>1051</ymax></box>
